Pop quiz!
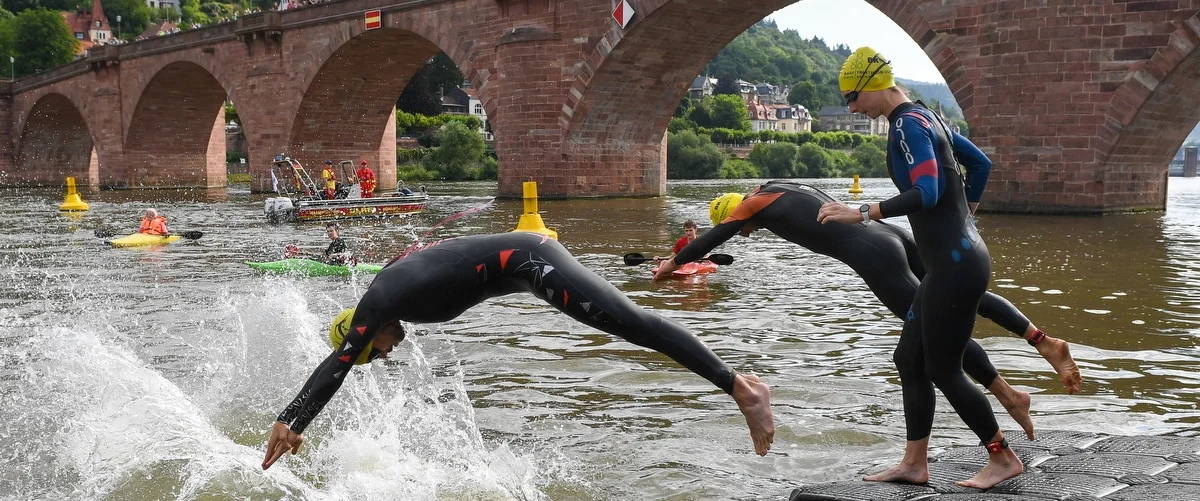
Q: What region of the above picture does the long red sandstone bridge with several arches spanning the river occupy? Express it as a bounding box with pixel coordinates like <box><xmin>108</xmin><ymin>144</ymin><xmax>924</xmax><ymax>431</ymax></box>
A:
<box><xmin>0</xmin><ymin>0</ymin><xmax>1200</xmax><ymax>212</ymax></box>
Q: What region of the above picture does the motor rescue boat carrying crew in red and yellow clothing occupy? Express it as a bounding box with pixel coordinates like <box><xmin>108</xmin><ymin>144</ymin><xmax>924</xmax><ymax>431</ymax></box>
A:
<box><xmin>263</xmin><ymin>156</ymin><xmax>430</xmax><ymax>223</ymax></box>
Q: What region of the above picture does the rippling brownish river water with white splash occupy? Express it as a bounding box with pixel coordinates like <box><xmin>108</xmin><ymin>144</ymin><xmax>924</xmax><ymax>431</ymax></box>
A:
<box><xmin>0</xmin><ymin>179</ymin><xmax>1200</xmax><ymax>500</ymax></box>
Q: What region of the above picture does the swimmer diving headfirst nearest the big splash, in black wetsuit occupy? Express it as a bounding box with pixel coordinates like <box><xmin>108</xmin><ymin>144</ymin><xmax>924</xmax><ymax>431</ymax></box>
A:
<box><xmin>263</xmin><ymin>231</ymin><xmax>775</xmax><ymax>469</ymax></box>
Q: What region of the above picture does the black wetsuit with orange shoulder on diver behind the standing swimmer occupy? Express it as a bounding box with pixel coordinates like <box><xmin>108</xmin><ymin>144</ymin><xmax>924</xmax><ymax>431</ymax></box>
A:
<box><xmin>674</xmin><ymin>181</ymin><xmax>1030</xmax><ymax>386</ymax></box>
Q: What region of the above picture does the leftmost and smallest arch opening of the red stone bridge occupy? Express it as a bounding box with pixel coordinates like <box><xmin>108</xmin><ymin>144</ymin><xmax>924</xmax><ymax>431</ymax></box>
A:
<box><xmin>15</xmin><ymin>92</ymin><xmax>100</xmax><ymax>186</ymax></box>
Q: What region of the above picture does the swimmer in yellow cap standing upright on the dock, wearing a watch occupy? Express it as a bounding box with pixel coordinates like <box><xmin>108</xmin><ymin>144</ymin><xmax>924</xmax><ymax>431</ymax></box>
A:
<box><xmin>817</xmin><ymin>47</ymin><xmax>1024</xmax><ymax>489</ymax></box>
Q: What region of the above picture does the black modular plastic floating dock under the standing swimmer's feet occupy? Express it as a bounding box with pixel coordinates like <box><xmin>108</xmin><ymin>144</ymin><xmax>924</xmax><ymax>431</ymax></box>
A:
<box><xmin>790</xmin><ymin>431</ymin><xmax>1200</xmax><ymax>501</ymax></box>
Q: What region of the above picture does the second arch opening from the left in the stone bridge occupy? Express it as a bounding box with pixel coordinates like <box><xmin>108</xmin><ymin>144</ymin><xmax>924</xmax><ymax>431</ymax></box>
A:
<box><xmin>122</xmin><ymin>61</ymin><xmax>227</xmax><ymax>187</ymax></box>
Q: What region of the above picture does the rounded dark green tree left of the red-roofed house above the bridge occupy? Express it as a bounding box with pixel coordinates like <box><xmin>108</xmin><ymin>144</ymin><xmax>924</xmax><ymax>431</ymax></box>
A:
<box><xmin>10</xmin><ymin>8</ymin><xmax>79</xmax><ymax>76</ymax></box>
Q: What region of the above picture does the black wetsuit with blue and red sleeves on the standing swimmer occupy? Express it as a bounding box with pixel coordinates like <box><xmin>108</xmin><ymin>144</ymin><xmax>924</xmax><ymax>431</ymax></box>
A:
<box><xmin>880</xmin><ymin>103</ymin><xmax>1000</xmax><ymax>442</ymax></box>
